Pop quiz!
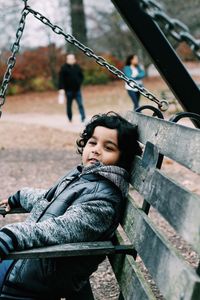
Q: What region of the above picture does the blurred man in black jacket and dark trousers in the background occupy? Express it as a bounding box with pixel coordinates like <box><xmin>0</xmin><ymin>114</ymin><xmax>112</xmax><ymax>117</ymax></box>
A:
<box><xmin>58</xmin><ymin>54</ymin><xmax>85</xmax><ymax>122</ymax></box>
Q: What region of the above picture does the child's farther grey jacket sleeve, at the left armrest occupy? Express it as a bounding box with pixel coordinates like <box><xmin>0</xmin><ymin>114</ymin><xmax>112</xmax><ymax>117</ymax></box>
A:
<box><xmin>8</xmin><ymin>188</ymin><xmax>47</xmax><ymax>212</ymax></box>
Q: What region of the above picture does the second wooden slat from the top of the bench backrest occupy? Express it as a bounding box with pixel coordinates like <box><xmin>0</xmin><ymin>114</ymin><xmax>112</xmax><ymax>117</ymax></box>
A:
<box><xmin>131</xmin><ymin>157</ymin><xmax>200</xmax><ymax>254</ymax></box>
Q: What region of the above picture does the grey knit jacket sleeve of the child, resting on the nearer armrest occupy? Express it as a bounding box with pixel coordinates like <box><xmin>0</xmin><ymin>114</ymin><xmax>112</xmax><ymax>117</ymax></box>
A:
<box><xmin>2</xmin><ymin>199</ymin><xmax>115</xmax><ymax>250</ymax></box>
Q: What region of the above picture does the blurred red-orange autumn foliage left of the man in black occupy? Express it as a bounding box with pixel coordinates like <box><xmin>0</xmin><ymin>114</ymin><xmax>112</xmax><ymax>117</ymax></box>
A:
<box><xmin>0</xmin><ymin>45</ymin><xmax>64</xmax><ymax>94</ymax></box>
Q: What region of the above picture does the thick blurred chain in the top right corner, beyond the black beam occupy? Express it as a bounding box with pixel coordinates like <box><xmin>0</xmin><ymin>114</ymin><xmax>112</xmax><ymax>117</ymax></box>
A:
<box><xmin>140</xmin><ymin>0</ymin><xmax>200</xmax><ymax>59</ymax></box>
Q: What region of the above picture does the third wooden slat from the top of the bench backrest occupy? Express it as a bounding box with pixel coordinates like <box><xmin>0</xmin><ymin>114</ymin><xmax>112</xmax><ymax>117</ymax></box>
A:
<box><xmin>122</xmin><ymin>198</ymin><xmax>200</xmax><ymax>300</ymax></box>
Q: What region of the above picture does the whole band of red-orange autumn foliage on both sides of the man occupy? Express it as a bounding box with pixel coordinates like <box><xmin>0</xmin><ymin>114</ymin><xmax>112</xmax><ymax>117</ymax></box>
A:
<box><xmin>0</xmin><ymin>44</ymin><xmax>122</xmax><ymax>94</ymax></box>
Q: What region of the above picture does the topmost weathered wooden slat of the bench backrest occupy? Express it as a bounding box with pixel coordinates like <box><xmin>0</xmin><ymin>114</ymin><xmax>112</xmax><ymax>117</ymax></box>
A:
<box><xmin>126</xmin><ymin>112</ymin><xmax>200</xmax><ymax>174</ymax></box>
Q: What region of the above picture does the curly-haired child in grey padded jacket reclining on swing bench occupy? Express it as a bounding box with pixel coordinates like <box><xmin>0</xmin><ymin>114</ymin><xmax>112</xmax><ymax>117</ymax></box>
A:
<box><xmin>0</xmin><ymin>112</ymin><xmax>141</xmax><ymax>299</ymax></box>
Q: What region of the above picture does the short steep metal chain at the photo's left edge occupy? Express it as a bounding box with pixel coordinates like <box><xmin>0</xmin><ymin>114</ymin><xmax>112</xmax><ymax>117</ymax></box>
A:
<box><xmin>0</xmin><ymin>8</ymin><xmax>29</xmax><ymax>117</ymax></box>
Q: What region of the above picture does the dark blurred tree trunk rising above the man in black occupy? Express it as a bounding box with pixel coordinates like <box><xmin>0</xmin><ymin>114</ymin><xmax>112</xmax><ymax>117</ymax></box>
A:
<box><xmin>68</xmin><ymin>0</ymin><xmax>87</xmax><ymax>52</ymax></box>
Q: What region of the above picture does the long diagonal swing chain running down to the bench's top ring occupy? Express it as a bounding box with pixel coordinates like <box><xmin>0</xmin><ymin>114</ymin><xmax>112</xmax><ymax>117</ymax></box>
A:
<box><xmin>27</xmin><ymin>6</ymin><xmax>168</xmax><ymax>111</ymax></box>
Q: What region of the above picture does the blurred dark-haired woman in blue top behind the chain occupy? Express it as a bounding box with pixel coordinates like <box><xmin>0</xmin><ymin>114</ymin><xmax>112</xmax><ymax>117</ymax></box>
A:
<box><xmin>123</xmin><ymin>54</ymin><xmax>145</xmax><ymax>109</ymax></box>
